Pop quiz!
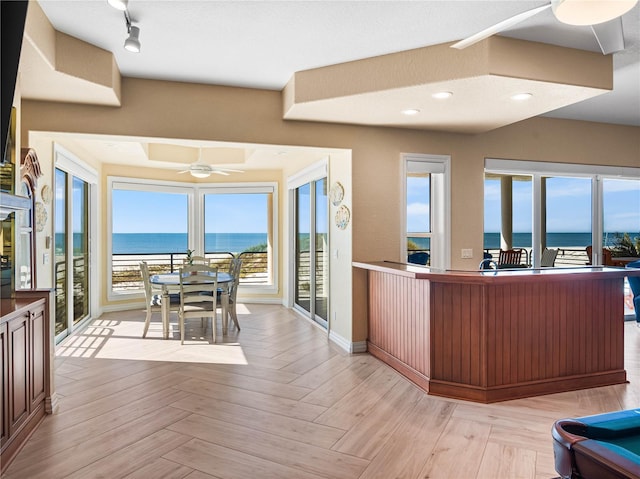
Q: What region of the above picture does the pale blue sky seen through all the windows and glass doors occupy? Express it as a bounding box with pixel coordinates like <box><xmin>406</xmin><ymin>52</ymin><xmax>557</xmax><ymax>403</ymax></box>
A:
<box><xmin>113</xmin><ymin>178</ymin><xmax>640</xmax><ymax>233</ymax></box>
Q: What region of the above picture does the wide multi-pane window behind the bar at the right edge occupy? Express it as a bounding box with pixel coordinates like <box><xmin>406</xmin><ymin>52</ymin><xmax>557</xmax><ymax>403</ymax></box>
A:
<box><xmin>484</xmin><ymin>159</ymin><xmax>640</xmax><ymax>267</ymax></box>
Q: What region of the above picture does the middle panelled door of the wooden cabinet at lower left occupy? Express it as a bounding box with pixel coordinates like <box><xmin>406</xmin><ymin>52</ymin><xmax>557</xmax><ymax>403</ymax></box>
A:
<box><xmin>8</xmin><ymin>313</ymin><xmax>29</xmax><ymax>436</ymax></box>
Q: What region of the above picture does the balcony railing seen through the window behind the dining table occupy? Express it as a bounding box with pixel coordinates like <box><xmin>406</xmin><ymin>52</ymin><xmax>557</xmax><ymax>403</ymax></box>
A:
<box><xmin>111</xmin><ymin>251</ymin><xmax>270</xmax><ymax>292</ymax></box>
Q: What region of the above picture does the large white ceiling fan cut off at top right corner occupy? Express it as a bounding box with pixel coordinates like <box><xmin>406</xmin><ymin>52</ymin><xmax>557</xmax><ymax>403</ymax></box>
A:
<box><xmin>451</xmin><ymin>0</ymin><xmax>638</xmax><ymax>55</ymax></box>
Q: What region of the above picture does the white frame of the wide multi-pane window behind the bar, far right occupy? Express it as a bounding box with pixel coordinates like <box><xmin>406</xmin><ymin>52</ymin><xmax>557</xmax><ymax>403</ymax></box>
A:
<box><xmin>484</xmin><ymin>158</ymin><xmax>640</xmax><ymax>268</ymax></box>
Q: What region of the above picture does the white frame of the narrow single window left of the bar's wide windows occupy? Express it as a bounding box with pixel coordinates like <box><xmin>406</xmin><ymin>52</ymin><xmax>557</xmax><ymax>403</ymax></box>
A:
<box><xmin>399</xmin><ymin>153</ymin><xmax>451</xmax><ymax>269</ymax></box>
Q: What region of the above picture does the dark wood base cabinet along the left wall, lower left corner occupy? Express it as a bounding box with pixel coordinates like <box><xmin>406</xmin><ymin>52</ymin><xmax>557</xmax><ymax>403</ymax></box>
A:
<box><xmin>0</xmin><ymin>298</ymin><xmax>51</xmax><ymax>472</ymax></box>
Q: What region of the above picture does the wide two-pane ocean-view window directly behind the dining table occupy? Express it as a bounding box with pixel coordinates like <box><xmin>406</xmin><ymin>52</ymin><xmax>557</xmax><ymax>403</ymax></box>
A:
<box><xmin>108</xmin><ymin>177</ymin><xmax>277</xmax><ymax>300</ymax></box>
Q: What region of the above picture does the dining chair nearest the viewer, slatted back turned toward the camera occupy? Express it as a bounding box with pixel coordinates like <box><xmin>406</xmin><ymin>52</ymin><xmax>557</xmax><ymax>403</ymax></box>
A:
<box><xmin>178</xmin><ymin>264</ymin><xmax>218</xmax><ymax>344</ymax></box>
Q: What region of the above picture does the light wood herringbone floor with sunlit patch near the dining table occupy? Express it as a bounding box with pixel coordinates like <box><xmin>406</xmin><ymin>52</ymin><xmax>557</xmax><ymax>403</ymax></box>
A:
<box><xmin>6</xmin><ymin>305</ymin><xmax>640</xmax><ymax>479</ymax></box>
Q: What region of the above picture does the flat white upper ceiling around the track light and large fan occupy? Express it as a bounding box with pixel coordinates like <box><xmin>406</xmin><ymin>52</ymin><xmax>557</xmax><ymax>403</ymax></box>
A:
<box><xmin>26</xmin><ymin>0</ymin><xmax>640</xmax><ymax>171</ymax></box>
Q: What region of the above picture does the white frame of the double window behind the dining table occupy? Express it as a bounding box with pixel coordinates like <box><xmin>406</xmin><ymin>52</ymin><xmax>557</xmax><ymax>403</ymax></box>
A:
<box><xmin>106</xmin><ymin>176</ymin><xmax>279</xmax><ymax>301</ymax></box>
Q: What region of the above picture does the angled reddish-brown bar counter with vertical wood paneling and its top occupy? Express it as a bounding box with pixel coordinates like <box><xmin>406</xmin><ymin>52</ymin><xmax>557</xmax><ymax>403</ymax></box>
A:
<box><xmin>353</xmin><ymin>262</ymin><xmax>640</xmax><ymax>403</ymax></box>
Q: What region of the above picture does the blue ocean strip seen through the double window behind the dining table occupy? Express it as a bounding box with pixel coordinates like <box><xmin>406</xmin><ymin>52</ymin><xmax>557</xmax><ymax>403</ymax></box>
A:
<box><xmin>112</xmin><ymin>233</ymin><xmax>267</xmax><ymax>254</ymax></box>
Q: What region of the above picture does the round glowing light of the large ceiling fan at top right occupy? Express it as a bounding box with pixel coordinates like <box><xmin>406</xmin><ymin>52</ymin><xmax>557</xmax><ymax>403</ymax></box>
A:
<box><xmin>551</xmin><ymin>0</ymin><xmax>638</xmax><ymax>25</ymax></box>
